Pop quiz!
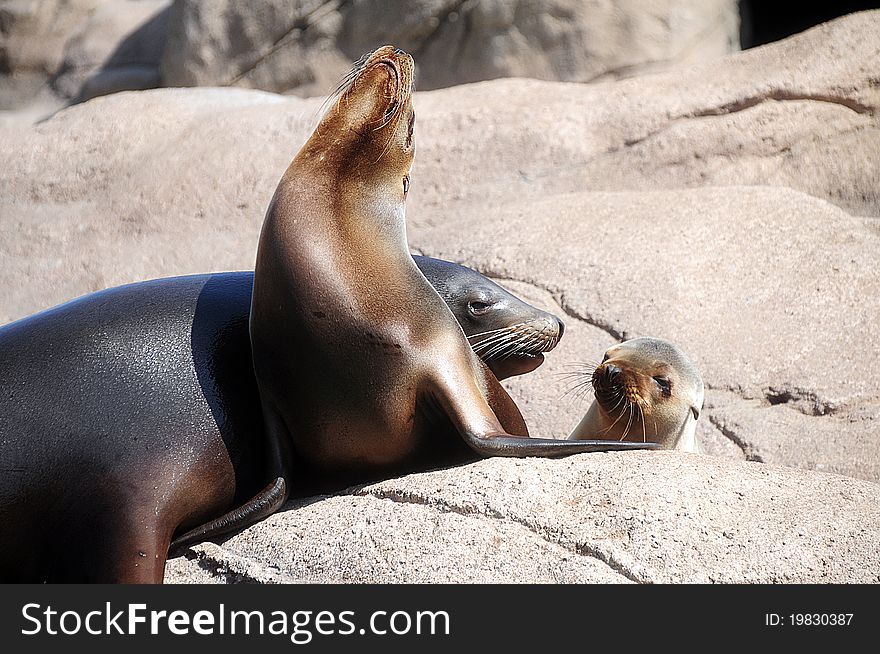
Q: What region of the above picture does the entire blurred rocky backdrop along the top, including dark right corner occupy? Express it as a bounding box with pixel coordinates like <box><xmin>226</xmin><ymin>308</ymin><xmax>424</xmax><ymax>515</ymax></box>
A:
<box><xmin>0</xmin><ymin>0</ymin><xmax>877</xmax><ymax>124</ymax></box>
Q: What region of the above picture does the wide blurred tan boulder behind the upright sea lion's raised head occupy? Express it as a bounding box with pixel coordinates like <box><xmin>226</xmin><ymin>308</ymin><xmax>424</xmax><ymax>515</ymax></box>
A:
<box><xmin>162</xmin><ymin>0</ymin><xmax>739</xmax><ymax>96</ymax></box>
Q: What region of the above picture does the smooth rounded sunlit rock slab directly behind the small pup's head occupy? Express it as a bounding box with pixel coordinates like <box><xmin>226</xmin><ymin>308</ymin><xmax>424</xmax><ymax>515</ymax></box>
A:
<box><xmin>413</xmin><ymin>187</ymin><xmax>880</xmax><ymax>415</ymax></box>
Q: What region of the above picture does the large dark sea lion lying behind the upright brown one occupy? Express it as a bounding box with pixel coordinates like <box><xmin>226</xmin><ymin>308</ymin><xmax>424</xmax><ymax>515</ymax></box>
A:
<box><xmin>0</xmin><ymin>257</ymin><xmax>556</xmax><ymax>582</ymax></box>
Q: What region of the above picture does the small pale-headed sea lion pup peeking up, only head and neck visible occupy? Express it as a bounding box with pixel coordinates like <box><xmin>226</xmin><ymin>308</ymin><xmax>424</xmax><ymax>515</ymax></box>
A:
<box><xmin>568</xmin><ymin>338</ymin><xmax>703</xmax><ymax>452</ymax></box>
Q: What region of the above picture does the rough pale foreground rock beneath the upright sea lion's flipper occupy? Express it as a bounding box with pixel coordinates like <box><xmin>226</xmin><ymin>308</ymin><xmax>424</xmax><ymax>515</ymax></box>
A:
<box><xmin>165</xmin><ymin>452</ymin><xmax>880</xmax><ymax>583</ymax></box>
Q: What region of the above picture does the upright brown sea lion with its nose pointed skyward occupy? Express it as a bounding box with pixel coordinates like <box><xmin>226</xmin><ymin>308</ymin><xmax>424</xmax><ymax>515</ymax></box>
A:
<box><xmin>250</xmin><ymin>46</ymin><xmax>653</xmax><ymax>495</ymax></box>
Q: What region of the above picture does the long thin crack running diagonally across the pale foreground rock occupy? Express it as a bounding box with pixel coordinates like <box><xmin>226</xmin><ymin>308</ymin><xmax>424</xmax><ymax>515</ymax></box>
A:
<box><xmin>354</xmin><ymin>489</ymin><xmax>651</xmax><ymax>584</ymax></box>
